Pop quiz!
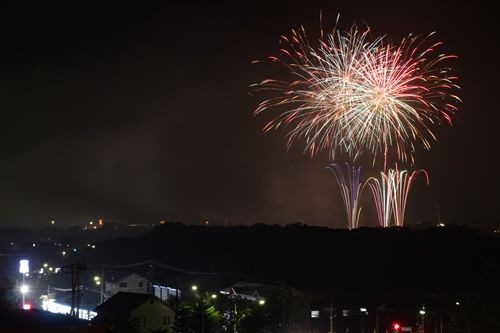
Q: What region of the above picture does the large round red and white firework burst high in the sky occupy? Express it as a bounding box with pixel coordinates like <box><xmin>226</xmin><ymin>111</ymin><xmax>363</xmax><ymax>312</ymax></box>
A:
<box><xmin>250</xmin><ymin>19</ymin><xmax>460</xmax><ymax>163</ymax></box>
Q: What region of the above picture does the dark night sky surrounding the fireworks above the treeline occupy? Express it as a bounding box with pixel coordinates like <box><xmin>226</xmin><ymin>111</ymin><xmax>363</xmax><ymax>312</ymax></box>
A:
<box><xmin>0</xmin><ymin>1</ymin><xmax>500</xmax><ymax>227</ymax></box>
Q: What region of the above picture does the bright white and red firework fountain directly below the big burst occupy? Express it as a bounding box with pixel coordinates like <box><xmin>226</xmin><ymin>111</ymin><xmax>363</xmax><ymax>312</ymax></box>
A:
<box><xmin>367</xmin><ymin>166</ymin><xmax>429</xmax><ymax>227</ymax></box>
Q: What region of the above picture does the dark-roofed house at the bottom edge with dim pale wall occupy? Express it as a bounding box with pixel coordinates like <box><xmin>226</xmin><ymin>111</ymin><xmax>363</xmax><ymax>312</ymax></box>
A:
<box><xmin>92</xmin><ymin>292</ymin><xmax>175</xmax><ymax>333</ymax></box>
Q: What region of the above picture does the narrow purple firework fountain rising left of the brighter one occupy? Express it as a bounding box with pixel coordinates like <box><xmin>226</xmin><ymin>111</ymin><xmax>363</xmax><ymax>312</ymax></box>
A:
<box><xmin>327</xmin><ymin>163</ymin><xmax>364</xmax><ymax>229</ymax></box>
